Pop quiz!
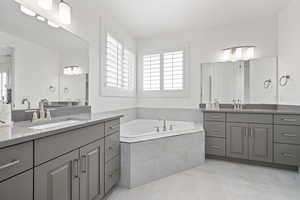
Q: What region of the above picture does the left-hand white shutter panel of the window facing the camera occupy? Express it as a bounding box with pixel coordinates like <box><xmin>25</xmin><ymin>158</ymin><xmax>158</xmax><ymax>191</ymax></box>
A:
<box><xmin>143</xmin><ymin>54</ymin><xmax>161</xmax><ymax>90</ymax></box>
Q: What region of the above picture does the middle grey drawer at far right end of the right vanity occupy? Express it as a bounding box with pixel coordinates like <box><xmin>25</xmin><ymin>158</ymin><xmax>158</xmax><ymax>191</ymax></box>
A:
<box><xmin>274</xmin><ymin>125</ymin><xmax>300</xmax><ymax>144</ymax></box>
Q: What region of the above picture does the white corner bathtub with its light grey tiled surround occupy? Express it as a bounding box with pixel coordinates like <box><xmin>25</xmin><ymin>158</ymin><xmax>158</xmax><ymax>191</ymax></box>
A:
<box><xmin>120</xmin><ymin>120</ymin><xmax>205</xmax><ymax>188</ymax></box>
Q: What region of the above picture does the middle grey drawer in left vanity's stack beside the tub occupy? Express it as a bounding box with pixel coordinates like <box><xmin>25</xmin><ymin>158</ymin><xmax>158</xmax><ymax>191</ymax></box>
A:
<box><xmin>105</xmin><ymin>132</ymin><xmax>120</xmax><ymax>162</ymax></box>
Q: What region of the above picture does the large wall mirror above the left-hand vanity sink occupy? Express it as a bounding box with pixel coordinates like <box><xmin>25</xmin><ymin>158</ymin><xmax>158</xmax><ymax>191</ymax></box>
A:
<box><xmin>0</xmin><ymin>0</ymin><xmax>89</xmax><ymax>109</ymax></box>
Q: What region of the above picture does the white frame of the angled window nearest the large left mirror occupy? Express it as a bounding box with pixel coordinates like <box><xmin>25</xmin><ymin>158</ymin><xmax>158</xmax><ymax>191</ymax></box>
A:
<box><xmin>100</xmin><ymin>31</ymin><xmax>137</xmax><ymax>97</ymax></box>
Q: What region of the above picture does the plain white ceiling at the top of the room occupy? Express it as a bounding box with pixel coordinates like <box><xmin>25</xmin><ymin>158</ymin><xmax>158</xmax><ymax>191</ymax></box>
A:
<box><xmin>101</xmin><ymin>0</ymin><xmax>290</xmax><ymax>38</ymax></box>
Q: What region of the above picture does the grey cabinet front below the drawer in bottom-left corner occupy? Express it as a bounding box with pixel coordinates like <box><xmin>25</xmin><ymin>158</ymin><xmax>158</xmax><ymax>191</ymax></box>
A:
<box><xmin>0</xmin><ymin>170</ymin><xmax>33</xmax><ymax>200</ymax></box>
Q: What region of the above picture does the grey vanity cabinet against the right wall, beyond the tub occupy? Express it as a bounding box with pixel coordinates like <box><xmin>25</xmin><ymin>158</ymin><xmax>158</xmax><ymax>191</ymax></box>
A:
<box><xmin>203</xmin><ymin>109</ymin><xmax>300</xmax><ymax>169</ymax></box>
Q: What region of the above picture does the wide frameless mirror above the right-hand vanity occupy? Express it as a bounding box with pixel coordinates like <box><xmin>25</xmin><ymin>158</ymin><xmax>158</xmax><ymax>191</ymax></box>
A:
<box><xmin>201</xmin><ymin>57</ymin><xmax>278</xmax><ymax>104</ymax></box>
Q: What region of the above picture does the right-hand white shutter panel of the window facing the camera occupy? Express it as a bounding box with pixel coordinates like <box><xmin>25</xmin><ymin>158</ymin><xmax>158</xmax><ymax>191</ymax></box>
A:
<box><xmin>163</xmin><ymin>51</ymin><xmax>184</xmax><ymax>90</ymax></box>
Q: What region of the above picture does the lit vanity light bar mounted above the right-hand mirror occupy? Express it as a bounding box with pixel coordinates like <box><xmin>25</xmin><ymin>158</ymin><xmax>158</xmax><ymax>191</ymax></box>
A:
<box><xmin>222</xmin><ymin>46</ymin><xmax>255</xmax><ymax>62</ymax></box>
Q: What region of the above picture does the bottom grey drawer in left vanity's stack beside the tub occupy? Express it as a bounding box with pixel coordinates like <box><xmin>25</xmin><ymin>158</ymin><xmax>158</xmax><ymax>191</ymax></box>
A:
<box><xmin>105</xmin><ymin>156</ymin><xmax>120</xmax><ymax>193</ymax></box>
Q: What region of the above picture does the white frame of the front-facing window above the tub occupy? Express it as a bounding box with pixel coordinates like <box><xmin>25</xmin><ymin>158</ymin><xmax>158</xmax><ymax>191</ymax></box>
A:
<box><xmin>137</xmin><ymin>45</ymin><xmax>189</xmax><ymax>98</ymax></box>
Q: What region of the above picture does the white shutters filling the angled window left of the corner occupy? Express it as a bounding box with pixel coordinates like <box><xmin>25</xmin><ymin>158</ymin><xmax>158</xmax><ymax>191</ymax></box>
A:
<box><xmin>105</xmin><ymin>34</ymin><xmax>135</xmax><ymax>90</ymax></box>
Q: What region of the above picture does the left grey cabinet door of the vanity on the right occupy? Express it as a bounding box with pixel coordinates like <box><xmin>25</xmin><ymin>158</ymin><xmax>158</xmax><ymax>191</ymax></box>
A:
<box><xmin>226</xmin><ymin>123</ymin><xmax>248</xmax><ymax>159</ymax></box>
